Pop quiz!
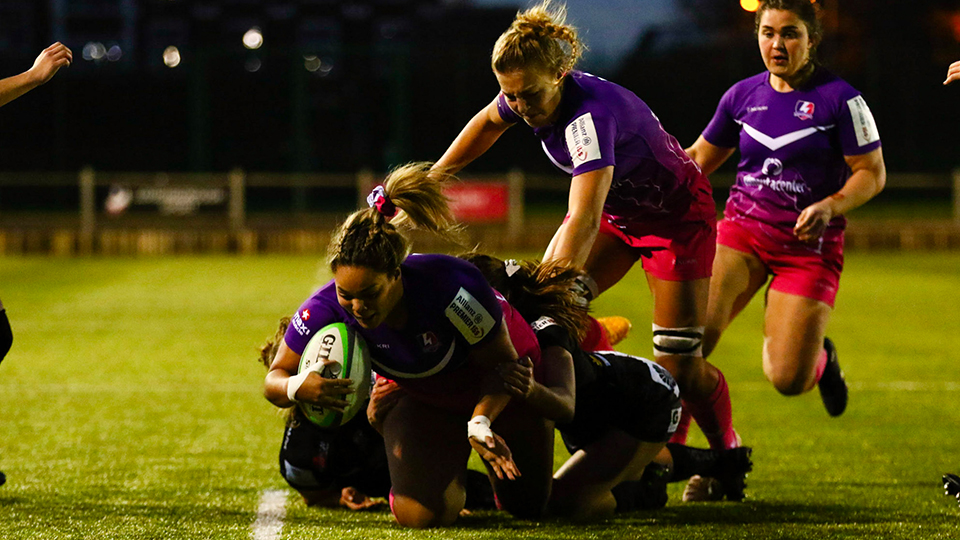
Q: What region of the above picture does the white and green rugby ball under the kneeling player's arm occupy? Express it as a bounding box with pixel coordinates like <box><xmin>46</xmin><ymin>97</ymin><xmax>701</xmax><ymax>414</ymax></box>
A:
<box><xmin>297</xmin><ymin>323</ymin><xmax>371</xmax><ymax>427</ymax></box>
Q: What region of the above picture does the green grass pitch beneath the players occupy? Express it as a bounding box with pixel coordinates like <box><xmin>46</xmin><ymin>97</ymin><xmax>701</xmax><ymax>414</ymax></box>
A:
<box><xmin>0</xmin><ymin>253</ymin><xmax>960</xmax><ymax>540</ymax></box>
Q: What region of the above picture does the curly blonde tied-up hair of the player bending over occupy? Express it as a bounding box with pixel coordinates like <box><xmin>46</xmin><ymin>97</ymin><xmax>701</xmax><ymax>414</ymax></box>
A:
<box><xmin>490</xmin><ymin>0</ymin><xmax>586</xmax><ymax>73</ymax></box>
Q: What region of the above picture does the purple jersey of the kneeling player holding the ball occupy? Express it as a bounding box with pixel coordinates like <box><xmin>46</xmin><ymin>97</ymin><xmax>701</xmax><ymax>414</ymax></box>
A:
<box><xmin>284</xmin><ymin>254</ymin><xmax>503</xmax><ymax>380</ymax></box>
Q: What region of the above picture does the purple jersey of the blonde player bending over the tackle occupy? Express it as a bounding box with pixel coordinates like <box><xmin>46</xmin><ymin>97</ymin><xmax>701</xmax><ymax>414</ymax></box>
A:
<box><xmin>497</xmin><ymin>71</ymin><xmax>715</xmax><ymax>224</ymax></box>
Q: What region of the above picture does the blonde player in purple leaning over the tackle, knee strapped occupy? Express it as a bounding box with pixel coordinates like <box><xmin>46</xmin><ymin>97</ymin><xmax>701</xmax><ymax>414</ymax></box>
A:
<box><xmin>436</xmin><ymin>2</ymin><xmax>740</xmax><ymax>486</ymax></box>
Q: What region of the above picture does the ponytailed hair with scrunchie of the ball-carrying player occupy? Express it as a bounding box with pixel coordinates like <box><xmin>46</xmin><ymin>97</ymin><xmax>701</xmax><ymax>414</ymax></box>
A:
<box><xmin>328</xmin><ymin>162</ymin><xmax>461</xmax><ymax>275</ymax></box>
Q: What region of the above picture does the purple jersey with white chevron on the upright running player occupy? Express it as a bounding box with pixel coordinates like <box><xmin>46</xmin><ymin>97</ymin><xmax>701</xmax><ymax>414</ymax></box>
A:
<box><xmin>703</xmin><ymin>68</ymin><xmax>880</xmax><ymax>236</ymax></box>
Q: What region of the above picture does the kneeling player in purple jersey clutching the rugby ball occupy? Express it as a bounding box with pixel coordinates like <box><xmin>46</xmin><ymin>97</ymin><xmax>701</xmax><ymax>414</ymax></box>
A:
<box><xmin>264</xmin><ymin>164</ymin><xmax>553</xmax><ymax>527</ymax></box>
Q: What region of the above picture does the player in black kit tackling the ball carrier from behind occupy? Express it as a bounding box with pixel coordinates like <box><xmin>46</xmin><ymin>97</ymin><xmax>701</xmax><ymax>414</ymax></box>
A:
<box><xmin>463</xmin><ymin>253</ymin><xmax>751</xmax><ymax>517</ymax></box>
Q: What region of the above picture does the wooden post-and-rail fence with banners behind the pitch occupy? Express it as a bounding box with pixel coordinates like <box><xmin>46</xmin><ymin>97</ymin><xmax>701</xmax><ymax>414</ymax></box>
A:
<box><xmin>0</xmin><ymin>168</ymin><xmax>960</xmax><ymax>255</ymax></box>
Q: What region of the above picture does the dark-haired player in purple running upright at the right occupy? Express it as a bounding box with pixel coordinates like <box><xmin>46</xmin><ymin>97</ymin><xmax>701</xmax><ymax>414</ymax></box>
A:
<box><xmin>687</xmin><ymin>0</ymin><xmax>886</xmax><ymax>486</ymax></box>
